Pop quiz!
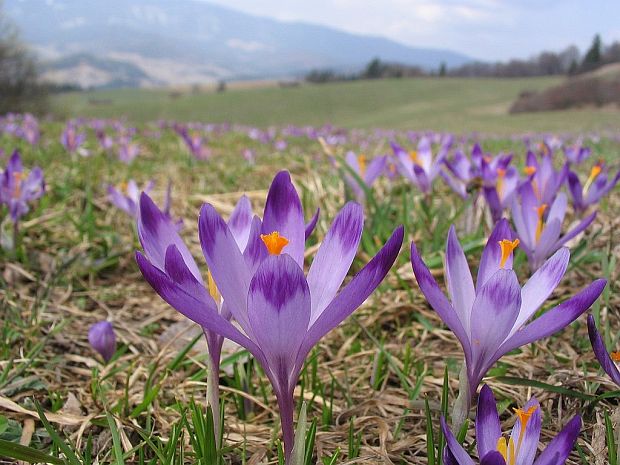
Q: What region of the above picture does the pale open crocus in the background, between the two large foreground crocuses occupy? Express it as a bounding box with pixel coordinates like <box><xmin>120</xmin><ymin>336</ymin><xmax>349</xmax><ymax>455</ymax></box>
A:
<box><xmin>391</xmin><ymin>137</ymin><xmax>451</xmax><ymax>195</ymax></box>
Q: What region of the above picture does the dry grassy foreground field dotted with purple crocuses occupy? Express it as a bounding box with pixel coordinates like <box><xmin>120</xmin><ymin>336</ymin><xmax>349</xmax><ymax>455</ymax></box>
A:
<box><xmin>0</xmin><ymin>110</ymin><xmax>620</xmax><ymax>465</ymax></box>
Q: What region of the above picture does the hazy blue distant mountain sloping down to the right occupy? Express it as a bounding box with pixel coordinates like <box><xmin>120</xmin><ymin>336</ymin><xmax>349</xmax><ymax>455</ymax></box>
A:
<box><xmin>4</xmin><ymin>0</ymin><xmax>471</xmax><ymax>87</ymax></box>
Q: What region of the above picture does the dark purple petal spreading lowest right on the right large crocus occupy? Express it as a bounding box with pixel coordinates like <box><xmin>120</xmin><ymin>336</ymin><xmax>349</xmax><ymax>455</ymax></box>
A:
<box><xmin>496</xmin><ymin>279</ymin><xmax>607</xmax><ymax>358</ymax></box>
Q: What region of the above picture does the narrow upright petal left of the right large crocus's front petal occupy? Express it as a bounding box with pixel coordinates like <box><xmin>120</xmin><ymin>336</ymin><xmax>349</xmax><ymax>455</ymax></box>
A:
<box><xmin>445</xmin><ymin>225</ymin><xmax>476</xmax><ymax>334</ymax></box>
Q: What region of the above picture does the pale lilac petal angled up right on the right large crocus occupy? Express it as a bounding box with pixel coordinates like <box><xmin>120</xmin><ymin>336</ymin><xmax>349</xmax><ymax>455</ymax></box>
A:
<box><xmin>513</xmin><ymin>248</ymin><xmax>570</xmax><ymax>334</ymax></box>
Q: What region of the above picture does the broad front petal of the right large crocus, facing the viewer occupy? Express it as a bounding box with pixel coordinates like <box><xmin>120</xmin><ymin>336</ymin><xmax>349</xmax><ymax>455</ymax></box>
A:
<box><xmin>468</xmin><ymin>270</ymin><xmax>521</xmax><ymax>384</ymax></box>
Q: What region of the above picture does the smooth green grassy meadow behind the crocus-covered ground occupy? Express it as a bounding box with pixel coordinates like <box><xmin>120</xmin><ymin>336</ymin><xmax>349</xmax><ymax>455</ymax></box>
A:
<box><xmin>53</xmin><ymin>78</ymin><xmax>620</xmax><ymax>135</ymax></box>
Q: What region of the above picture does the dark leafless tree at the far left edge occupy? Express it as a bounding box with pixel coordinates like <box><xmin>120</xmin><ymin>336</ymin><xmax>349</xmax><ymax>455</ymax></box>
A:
<box><xmin>0</xmin><ymin>0</ymin><xmax>47</xmax><ymax>114</ymax></box>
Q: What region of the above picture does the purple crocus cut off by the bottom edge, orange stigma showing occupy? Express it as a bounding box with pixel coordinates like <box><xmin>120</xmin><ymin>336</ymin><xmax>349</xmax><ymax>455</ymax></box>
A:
<box><xmin>441</xmin><ymin>385</ymin><xmax>581</xmax><ymax>465</ymax></box>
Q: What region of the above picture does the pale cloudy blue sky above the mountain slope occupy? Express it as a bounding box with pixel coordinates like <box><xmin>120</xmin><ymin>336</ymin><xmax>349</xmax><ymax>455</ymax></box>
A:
<box><xmin>201</xmin><ymin>0</ymin><xmax>620</xmax><ymax>60</ymax></box>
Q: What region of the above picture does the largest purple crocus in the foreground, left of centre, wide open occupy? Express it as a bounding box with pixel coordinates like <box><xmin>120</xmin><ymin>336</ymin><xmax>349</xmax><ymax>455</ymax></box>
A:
<box><xmin>136</xmin><ymin>171</ymin><xmax>403</xmax><ymax>460</ymax></box>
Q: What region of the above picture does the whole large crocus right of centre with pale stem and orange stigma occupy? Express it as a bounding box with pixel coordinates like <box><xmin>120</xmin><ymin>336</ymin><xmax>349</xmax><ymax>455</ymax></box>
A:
<box><xmin>411</xmin><ymin>219</ymin><xmax>606</xmax><ymax>427</ymax></box>
